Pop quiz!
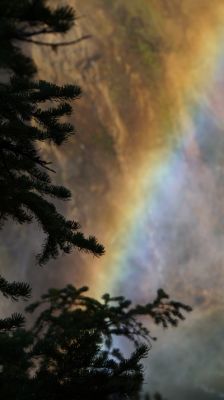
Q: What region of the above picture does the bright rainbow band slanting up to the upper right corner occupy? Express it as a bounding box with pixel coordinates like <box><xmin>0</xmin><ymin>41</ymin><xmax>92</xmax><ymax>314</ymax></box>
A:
<box><xmin>87</xmin><ymin>0</ymin><xmax>224</xmax><ymax>298</ymax></box>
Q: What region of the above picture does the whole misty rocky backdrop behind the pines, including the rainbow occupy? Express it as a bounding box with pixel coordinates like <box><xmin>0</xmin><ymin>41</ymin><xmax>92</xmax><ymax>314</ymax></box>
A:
<box><xmin>1</xmin><ymin>0</ymin><xmax>224</xmax><ymax>399</ymax></box>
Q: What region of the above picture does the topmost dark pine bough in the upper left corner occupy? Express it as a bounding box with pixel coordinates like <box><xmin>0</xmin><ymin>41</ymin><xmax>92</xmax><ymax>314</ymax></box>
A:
<box><xmin>0</xmin><ymin>0</ymin><xmax>75</xmax><ymax>77</ymax></box>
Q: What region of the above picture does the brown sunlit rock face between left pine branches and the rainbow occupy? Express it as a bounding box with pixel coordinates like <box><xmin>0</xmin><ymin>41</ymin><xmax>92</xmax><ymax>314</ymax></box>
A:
<box><xmin>23</xmin><ymin>0</ymin><xmax>168</xmax><ymax>290</ymax></box>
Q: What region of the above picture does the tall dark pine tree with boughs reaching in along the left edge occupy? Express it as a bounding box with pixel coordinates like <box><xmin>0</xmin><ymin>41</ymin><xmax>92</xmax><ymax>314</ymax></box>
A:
<box><xmin>0</xmin><ymin>0</ymin><xmax>104</xmax><ymax>330</ymax></box>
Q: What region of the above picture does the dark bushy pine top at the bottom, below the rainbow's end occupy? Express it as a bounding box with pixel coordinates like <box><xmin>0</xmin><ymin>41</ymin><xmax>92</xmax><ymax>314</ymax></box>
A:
<box><xmin>0</xmin><ymin>285</ymin><xmax>190</xmax><ymax>400</ymax></box>
